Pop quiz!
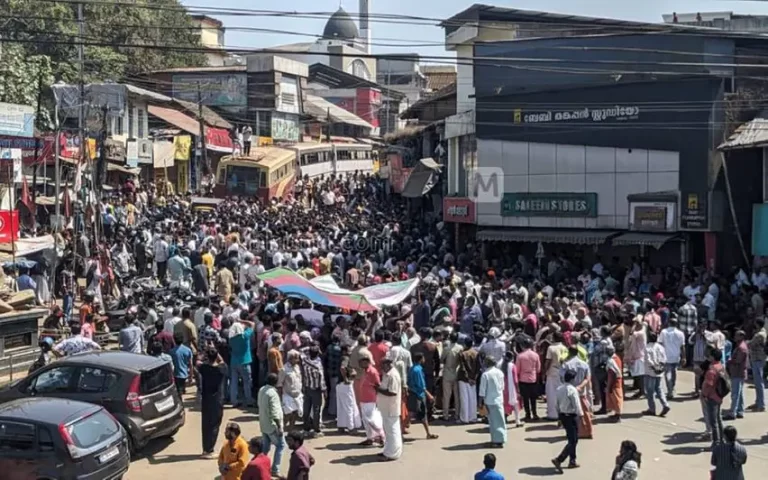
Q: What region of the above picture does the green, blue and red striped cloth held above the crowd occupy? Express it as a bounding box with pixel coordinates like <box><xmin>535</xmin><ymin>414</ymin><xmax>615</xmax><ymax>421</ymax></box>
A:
<box><xmin>257</xmin><ymin>268</ymin><xmax>377</xmax><ymax>312</ymax></box>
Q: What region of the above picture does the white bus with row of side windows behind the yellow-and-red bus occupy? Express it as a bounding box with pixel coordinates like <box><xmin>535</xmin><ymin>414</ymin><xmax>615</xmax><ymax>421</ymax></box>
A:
<box><xmin>286</xmin><ymin>143</ymin><xmax>376</xmax><ymax>178</ymax></box>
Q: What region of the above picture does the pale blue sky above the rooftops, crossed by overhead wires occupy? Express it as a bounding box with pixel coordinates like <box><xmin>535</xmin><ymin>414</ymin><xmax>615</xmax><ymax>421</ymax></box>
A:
<box><xmin>182</xmin><ymin>0</ymin><xmax>768</xmax><ymax>55</ymax></box>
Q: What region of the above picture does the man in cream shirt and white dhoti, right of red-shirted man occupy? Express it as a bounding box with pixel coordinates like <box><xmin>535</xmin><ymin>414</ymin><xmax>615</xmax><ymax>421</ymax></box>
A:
<box><xmin>376</xmin><ymin>358</ymin><xmax>403</xmax><ymax>460</ymax></box>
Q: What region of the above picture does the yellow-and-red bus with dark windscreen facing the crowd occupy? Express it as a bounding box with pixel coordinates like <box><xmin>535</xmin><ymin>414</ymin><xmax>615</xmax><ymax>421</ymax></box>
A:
<box><xmin>213</xmin><ymin>147</ymin><xmax>296</xmax><ymax>202</ymax></box>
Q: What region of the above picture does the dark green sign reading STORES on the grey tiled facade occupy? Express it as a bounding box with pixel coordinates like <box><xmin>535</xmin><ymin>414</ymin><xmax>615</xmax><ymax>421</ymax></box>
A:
<box><xmin>501</xmin><ymin>193</ymin><xmax>597</xmax><ymax>218</ymax></box>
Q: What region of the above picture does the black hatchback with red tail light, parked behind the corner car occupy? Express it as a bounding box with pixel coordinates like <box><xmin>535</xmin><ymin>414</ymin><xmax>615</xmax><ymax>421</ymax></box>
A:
<box><xmin>0</xmin><ymin>351</ymin><xmax>185</xmax><ymax>453</ymax></box>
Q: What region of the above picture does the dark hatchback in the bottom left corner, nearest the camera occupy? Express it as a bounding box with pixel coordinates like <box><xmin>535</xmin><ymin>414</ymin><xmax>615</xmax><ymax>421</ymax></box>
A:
<box><xmin>0</xmin><ymin>397</ymin><xmax>131</xmax><ymax>480</ymax></box>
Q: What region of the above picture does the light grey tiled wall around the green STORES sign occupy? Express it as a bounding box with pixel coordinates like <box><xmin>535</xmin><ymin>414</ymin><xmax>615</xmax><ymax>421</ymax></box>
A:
<box><xmin>477</xmin><ymin>139</ymin><xmax>680</xmax><ymax>229</ymax></box>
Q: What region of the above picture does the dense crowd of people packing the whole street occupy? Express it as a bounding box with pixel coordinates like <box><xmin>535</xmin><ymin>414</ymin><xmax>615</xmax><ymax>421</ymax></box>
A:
<box><xmin>30</xmin><ymin>173</ymin><xmax>768</xmax><ymax>480</ymax></box>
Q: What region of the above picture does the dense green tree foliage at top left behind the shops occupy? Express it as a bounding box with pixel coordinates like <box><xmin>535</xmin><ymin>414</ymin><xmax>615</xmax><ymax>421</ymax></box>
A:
<box><xmin>0</xmin><ymin>0</ymin><xmax>205</xmax><ymax>94</ymax></box>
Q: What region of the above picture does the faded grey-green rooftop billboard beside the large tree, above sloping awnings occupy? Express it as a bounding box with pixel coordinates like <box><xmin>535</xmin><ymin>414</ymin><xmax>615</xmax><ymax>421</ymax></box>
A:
<box><xmin>173</xmin><ymin>73</ymin><xmax>248</xmax><ymax>107</ymax></box>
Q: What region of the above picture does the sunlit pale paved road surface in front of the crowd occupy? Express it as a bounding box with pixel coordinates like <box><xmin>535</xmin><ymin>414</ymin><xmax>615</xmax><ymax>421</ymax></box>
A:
<box><xmin>127</xmin><ymin>372</ymin><xmax>768</xmax><ymax>480</ymax></box>
